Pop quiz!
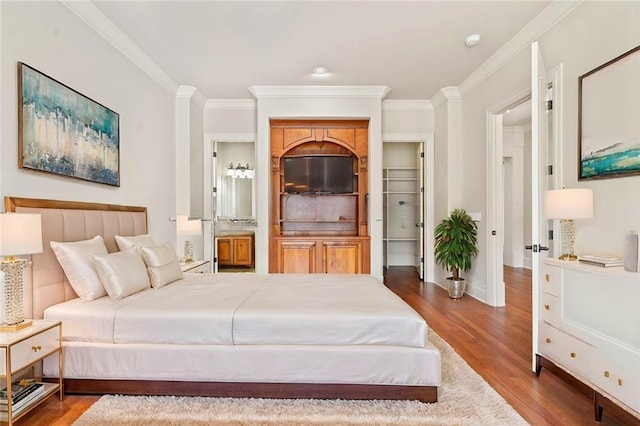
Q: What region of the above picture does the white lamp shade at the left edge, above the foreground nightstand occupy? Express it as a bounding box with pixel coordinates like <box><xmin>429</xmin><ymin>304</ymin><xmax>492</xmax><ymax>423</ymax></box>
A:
<box><xmin>0</xmin><ymin>213</ymin><xmax>42</xmax><ymax>256</ymax></box>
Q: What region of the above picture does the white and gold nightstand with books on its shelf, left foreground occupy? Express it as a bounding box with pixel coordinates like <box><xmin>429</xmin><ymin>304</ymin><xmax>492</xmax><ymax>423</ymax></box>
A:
<box><xmin>0</xmin><ymin>320</ymin><xmax>64</xmax><ymax>425</ymax></box>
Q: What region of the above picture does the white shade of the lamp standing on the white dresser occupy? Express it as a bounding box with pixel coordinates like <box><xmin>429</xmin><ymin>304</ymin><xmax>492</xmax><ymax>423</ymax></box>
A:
<box><xmin>544</xmin><ymin>188</ymin><xmax>593</xmax><ymax>219</ymax></box>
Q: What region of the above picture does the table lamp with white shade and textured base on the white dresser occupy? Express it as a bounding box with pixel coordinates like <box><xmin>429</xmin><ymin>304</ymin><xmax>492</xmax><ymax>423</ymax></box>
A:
<box><xmin>544</xmin><ymin>188</ymin><xmax>593</xmax><ymax>260</ymax></box>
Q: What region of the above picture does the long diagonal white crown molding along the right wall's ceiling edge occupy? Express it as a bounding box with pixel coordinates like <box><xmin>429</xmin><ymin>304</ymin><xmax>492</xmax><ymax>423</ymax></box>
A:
<box><xmin>458</xmin><ymin>0</ymin><xmax>583</xmax><ymax>96</ymax></box>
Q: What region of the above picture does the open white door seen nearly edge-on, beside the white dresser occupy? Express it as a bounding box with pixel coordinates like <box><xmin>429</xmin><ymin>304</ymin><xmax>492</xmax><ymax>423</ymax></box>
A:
<box><xmin>526</xmin><ymin>42</ymin><xmax>553</xmax><ymax>371</ymax></box>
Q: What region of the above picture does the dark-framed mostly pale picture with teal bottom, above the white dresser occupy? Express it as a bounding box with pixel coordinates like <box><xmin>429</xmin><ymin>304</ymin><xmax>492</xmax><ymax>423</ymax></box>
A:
<box><xmin>578</xmin><ymin>46</ymin><xmax>640</xmax><ymax>180</ymax></box>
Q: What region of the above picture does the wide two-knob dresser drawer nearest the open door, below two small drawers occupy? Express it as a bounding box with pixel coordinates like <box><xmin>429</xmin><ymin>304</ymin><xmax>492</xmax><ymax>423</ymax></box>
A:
<box><xmin>538</xmin><ymin>321</ymin><xmax>593</xmax><ymax>378</ymax></box>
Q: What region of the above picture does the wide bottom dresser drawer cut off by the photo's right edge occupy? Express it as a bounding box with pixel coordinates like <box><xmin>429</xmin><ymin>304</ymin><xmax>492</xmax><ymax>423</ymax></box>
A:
<box><xmin>590</xmin><ymin>349</ymin><xmax>640</xmax><ymax>412</ymax></box>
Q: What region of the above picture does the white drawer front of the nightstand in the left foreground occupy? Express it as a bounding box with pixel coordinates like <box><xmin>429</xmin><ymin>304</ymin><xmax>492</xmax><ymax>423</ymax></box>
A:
<box><xmin>0</xmin><ymin>325</ymin><xmax>60</xmax><ymax>375</ymax></box>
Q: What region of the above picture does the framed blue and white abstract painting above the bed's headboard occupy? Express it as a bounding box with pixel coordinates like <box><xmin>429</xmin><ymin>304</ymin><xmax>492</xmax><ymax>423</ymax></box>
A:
<box><xmin>18</xmin><ymin>62</ymin><xmax>120</xmax><ymax>187</ymax></box>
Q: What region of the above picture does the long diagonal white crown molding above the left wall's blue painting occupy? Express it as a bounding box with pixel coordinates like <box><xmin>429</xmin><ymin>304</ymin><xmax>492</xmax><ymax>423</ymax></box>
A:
<box><xmin>60</xmin><ymin>0</ymin><xmax>178</xmax><ymax>95</ymax></box>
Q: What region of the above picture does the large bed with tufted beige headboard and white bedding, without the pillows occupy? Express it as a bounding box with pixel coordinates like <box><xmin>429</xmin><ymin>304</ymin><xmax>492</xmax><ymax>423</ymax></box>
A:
<box><xmin>5</xmin><ymin>197</ymin><xmax>441</xmax><ymax>402</ymax></box>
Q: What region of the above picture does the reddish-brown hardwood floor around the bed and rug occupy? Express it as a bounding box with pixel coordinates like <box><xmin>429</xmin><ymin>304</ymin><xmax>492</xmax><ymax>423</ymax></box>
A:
<box><xmin>13</xmin><ymin>267</ymin><xmax>623</xmax><ymax>426</ymax></box>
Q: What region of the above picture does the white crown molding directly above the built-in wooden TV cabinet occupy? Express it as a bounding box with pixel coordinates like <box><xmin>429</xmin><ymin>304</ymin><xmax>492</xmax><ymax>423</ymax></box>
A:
<box><xmin>249</xmin><ymin>86</ymin><xmax>391</xmax><ymax>99</ymax></box>
